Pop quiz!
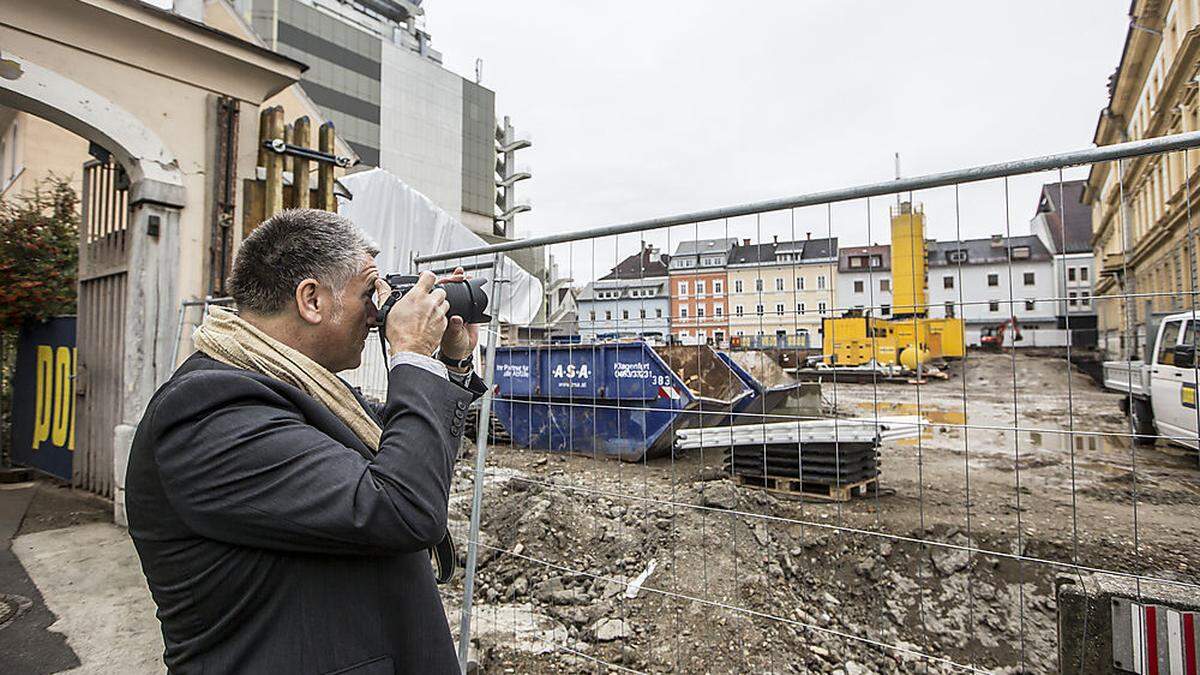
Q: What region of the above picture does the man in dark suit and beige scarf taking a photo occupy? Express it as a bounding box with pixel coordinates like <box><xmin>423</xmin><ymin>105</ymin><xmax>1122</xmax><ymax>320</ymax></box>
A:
<box><xmin>126</xmin><ymin>210</ymin><xmax>482</xmax><ymax>674</ymax></box>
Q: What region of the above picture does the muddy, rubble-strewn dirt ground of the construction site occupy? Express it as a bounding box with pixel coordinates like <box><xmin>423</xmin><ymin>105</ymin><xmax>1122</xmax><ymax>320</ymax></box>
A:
<box><xmin>445</xmin><ymin>353</ymin><xmax>1200</xmax><ymax>675</ymax></box>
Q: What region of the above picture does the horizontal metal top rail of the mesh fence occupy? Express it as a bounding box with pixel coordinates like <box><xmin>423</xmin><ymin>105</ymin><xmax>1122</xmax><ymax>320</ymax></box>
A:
<box><xmin>414</xmin><ymin>131</ymin><xmax>1200</xmax><ymax>264</ymax></box>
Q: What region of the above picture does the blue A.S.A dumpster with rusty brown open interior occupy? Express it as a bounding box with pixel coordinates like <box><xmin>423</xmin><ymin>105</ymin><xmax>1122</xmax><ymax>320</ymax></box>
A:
<box><xmin>493</xmin><ymin>341</ymin><xmax>752</xmax><ymax>461</ymax></box>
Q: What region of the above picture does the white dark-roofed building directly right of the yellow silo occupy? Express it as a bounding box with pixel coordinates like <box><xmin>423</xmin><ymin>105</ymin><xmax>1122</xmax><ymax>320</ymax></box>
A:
<box><xmin>926</xmin><ymin>234</ymin><xmax>1066</xmax><ymax>347</ymax></box>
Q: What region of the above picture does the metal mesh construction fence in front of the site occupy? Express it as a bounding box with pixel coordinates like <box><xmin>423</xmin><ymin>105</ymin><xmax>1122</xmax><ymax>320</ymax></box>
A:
<box><xmin>365</xmin><ymin>128</ymin><xmax>1200</xmax><ymax>673</ymax></box>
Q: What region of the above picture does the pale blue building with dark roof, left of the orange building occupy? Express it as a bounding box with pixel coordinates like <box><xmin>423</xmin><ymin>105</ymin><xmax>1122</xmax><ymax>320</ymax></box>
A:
<box><xmin>575</xmin><ymin>246</ymin><xmax>671</xmax><ymax>341</ymax></box>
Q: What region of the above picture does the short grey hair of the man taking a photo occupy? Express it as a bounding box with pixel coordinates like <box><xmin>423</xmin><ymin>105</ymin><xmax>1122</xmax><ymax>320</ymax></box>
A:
<box><xmin>229</xmin><ymin>209</ymin><xmax>379</xmax><ymax>315</ymax></box>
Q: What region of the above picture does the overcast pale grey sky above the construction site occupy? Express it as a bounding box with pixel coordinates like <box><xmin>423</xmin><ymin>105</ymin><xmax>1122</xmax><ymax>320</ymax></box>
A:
<box><xmin>424</xmin><ymin>0</ymin><xmax>1129</xmax><ymax>281</ymax></box>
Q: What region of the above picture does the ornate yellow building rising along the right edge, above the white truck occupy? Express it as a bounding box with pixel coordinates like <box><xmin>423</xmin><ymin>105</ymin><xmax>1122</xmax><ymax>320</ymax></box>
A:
<box><xmin>1084</xmin><ymin>0</ymin><xmax>1200</xmax><ymax>358</ymax></box>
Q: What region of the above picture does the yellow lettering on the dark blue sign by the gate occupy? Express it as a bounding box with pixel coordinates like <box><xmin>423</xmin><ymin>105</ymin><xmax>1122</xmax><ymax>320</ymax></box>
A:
<box><xmin>31</xmin><ymin>345</ymin><xmax>76</xmax><ymax>450</ymax></box>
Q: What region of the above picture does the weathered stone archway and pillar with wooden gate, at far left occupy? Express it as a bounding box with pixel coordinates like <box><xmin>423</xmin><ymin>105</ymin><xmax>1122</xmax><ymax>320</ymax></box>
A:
<box><xmin>0</xmin><ymin>54</ymin><xmax>187</xmax><ymax>496</ymax></box>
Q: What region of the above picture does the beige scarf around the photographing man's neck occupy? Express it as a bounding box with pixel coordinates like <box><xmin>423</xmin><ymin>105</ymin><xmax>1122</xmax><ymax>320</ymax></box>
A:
<box><xmin>192</xmin><ymin>307</ymin><xmax>383</xmax><ymax>452</ymax></box>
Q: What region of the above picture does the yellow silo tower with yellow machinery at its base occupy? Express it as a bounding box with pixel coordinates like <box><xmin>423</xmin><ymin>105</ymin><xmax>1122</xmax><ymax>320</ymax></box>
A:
<box><xmin>822</xmin><ymin>202</ymin><xmax>964</xmax><ymax>370</ymax></box>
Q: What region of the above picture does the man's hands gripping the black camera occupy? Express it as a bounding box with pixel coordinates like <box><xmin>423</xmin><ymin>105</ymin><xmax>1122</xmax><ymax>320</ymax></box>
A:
<box><xmin>376</xmin><ymin>267</ymin><xmax>479</xmax><ymax>359</ymax></box>
